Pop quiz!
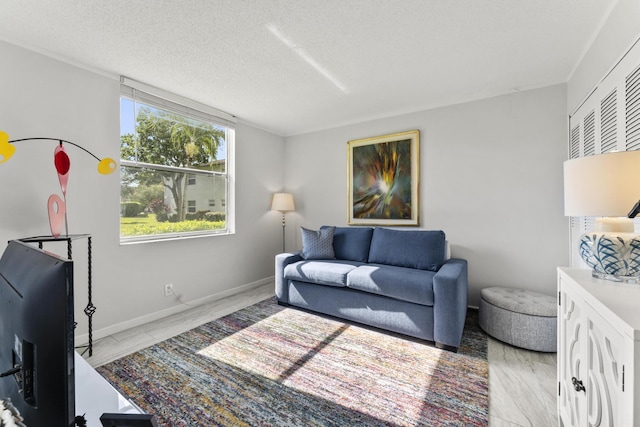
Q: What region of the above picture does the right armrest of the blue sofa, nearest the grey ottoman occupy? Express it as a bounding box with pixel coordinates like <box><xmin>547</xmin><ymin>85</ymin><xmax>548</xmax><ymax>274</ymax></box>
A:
<box><xmin>433</xmin><ymin>258</ymin><xmax>469</xmax><ymax>349</ymax></box>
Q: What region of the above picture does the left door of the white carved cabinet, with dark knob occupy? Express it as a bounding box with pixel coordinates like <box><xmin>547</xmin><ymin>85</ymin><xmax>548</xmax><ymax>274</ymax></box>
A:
<box><xmin>558</xmin><ymin>277</ymin><xmax>587</xmax><ymax>427</ymax></box>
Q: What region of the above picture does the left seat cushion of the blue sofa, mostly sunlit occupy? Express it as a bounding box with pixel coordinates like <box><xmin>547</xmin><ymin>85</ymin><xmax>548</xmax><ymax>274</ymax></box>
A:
<box><xmin>284</xmin><ymin>260</ymin><xmax>360</xmax><ymax>287</ymax></box>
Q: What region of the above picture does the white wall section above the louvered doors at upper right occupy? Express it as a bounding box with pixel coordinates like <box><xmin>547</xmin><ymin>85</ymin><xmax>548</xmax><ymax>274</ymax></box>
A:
<box><xmin>567</xmin><ymin>0</ymin><xmax>640</xmax><ymax>113</ymax></box>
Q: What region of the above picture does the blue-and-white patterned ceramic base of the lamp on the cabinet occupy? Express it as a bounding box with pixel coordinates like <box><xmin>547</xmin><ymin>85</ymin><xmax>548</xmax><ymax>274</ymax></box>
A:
<box><xmin>579</xmin><ymin>218</ymin><xmax>640</xmax><ymax>283</ymax></box>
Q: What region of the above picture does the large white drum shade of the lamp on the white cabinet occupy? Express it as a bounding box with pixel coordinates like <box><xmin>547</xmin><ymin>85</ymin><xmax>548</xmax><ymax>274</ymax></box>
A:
<box><xmin>564</xmin><ymin>151</ymin><xmax>640</xmax><ymax>217</ymax></box>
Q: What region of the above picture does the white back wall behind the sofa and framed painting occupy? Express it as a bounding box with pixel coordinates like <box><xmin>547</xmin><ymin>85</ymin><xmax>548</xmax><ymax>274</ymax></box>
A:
<box><xmin>285</xmin><ymin>85</ymin><xmax>569</xmax><ymax>306</ymax></box>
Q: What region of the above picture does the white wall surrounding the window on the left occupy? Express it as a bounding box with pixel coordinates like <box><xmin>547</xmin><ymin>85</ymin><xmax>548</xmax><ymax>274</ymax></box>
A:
<box><xmin>0</xmin><ymin>42</ymin><xmax>284</xmax><ymax>342</ymax></box>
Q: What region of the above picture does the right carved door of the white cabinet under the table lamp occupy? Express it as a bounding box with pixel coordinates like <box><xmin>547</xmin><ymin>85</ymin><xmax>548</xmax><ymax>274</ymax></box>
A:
<box><xmin>585</xmin><ymin>305</ymin><xmax>633</xmax><ymax>427</ymax></box>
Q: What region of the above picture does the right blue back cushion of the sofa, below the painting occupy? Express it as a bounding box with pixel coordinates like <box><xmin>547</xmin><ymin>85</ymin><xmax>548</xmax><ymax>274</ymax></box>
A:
<box><xmin>369</xmin><ymin>228</ymin><xmax>445</xmax><ymax>271</ymax></box>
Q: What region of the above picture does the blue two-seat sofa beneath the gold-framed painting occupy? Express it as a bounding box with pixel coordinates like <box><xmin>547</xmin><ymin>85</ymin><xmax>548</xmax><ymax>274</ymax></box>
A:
<box><xmin>275</xmin><ymin>226</ymin><xmax>468</xmax><ymax>351</ymax></box>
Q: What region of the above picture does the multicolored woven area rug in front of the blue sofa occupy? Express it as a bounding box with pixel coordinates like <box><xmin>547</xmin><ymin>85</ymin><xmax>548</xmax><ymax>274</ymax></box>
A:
<box><xmin>98</xmin><ymin>299</ymin><xmax>489</xmax><ymax>427</ymax></box>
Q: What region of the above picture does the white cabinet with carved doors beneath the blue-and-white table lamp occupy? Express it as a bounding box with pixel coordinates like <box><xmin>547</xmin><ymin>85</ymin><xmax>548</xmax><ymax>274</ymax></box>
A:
<box><xmin>558</xmin><ymin>268</ymin><xmax>640</xmax><ymax>427</ymax></box>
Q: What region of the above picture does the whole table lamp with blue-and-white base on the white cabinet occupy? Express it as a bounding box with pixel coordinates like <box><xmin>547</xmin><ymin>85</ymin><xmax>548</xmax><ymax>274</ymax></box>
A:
<box><xmin>564</xmin><ymin>151</ymin><xmax>640</xmax><ymax>283</ymax></box>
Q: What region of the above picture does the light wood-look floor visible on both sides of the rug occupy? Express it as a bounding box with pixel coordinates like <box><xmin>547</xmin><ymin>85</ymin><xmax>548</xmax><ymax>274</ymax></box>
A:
<box><xmin>87</xmin><ymin>284</ymin><xmax>558</xmax><ymax>427</ymax></box>
